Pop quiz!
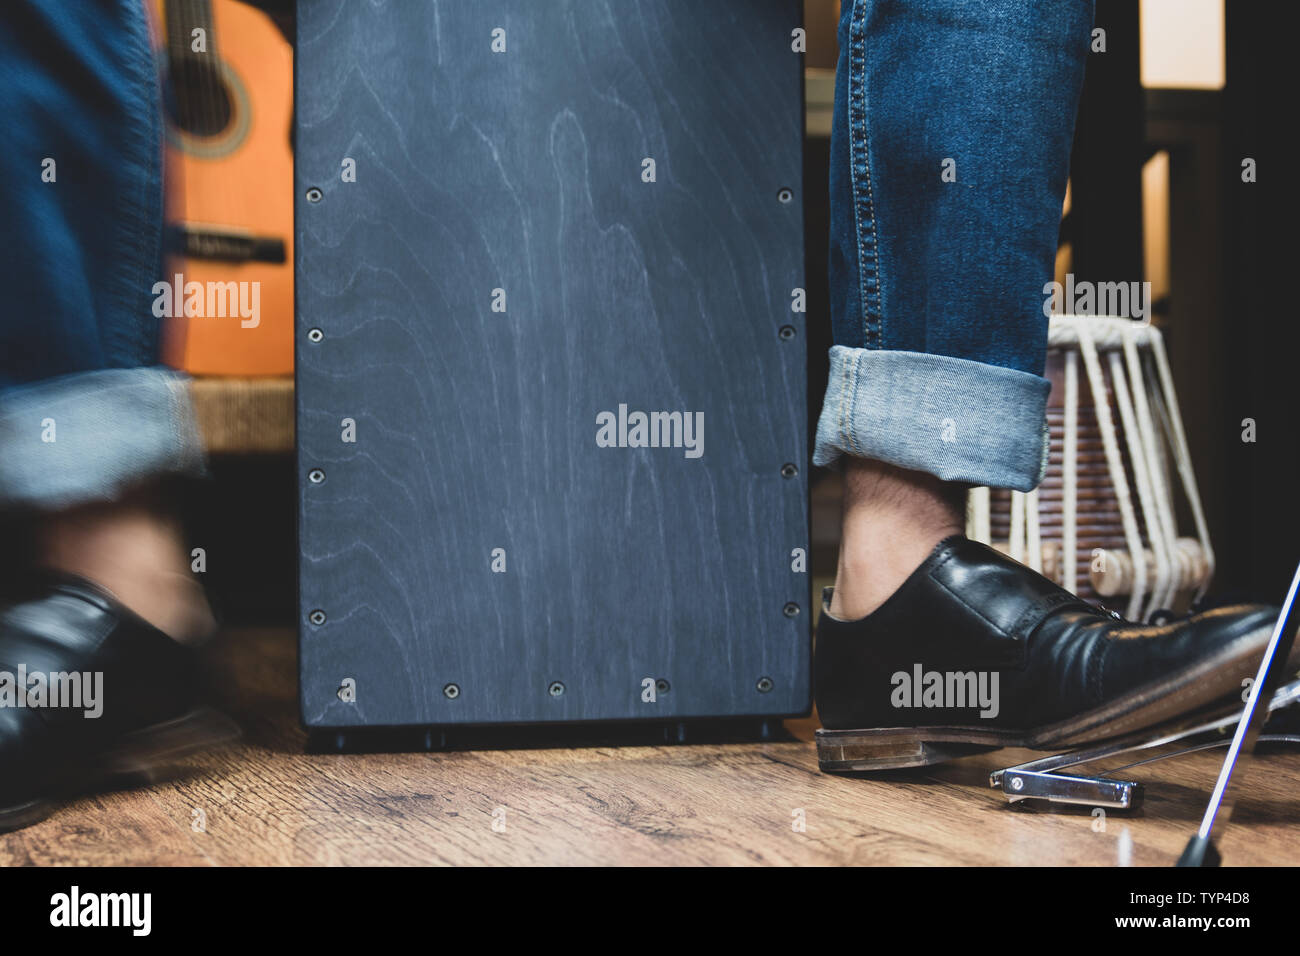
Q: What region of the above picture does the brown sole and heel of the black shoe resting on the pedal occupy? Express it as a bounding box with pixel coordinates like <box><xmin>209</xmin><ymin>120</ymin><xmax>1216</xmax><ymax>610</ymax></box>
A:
<box><xmin>816</xmin><ymin>624</ymin><xmax>1284</xmax><ymax>774</ymax></box>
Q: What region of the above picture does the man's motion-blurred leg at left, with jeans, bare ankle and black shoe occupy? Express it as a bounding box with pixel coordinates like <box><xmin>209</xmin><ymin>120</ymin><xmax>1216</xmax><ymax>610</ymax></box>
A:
<box><xmin>0</xmin><ymin>0</ymin><xmax>222</xmax><ymax>830</ymax></box>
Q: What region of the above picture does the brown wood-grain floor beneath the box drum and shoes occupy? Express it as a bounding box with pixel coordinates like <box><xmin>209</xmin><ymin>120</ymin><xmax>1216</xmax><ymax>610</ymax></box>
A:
<box><xmin>0</xmin><ymin>630</ymin><xmax>1300</xmax><ymax>866</ymax></box>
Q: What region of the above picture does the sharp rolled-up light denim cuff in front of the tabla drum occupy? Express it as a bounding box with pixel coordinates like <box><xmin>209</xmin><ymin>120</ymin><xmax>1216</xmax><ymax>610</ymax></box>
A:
<box><xmin>813</xmin><ymin>345</ymin><xmax>1052</xmax><ymax>492</ymax></box>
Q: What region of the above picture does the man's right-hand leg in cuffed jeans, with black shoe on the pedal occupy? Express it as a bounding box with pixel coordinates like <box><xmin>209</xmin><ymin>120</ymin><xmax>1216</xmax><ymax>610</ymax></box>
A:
<box><xmin>814</xmin><ymin>0</ymin><xmax>1271</xmax><ymax>770</ymax></box>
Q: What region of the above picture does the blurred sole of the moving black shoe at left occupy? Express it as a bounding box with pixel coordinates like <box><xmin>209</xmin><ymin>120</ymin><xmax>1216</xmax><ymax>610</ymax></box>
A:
<box><xmin>0</xmin><ymin>708</ymin><xmax>241</xmax><ymax>834</ymax></box>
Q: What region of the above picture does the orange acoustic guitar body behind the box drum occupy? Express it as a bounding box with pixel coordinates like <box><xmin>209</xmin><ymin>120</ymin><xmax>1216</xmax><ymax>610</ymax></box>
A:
<box><xmin>161</xmin><ymin>0</ymin><xmax>294</xmax><ymax>376</ymax></box>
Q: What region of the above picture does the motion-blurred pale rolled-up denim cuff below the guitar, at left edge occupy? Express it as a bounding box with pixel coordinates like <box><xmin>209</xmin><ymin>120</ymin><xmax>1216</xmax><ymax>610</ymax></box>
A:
<box><xmin>0</xmin><ymin>368</ymin><xmax>204</xmax><ymax>510</ymax></box>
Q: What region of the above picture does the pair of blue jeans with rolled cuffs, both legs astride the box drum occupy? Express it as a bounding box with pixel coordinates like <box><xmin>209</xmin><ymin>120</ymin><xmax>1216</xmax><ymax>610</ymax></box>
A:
<box><xmin>0</xmin><ymin>0</ymin><xmax>1092</xmax><ymax>507</ymax></box>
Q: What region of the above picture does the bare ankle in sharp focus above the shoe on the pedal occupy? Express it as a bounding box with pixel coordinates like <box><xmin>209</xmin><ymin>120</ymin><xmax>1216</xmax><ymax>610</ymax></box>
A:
<box><xmin>831</xmin><ymin>458</ymin><xmax>966</xmax><ymax>620</ymax></box>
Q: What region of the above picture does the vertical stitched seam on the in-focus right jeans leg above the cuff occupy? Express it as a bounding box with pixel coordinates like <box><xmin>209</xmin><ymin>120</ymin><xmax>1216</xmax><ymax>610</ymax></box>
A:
<box><xmin>849</xmin><ymin>0</ymin><xmax>884</xmax><ymax>349</ymax></box>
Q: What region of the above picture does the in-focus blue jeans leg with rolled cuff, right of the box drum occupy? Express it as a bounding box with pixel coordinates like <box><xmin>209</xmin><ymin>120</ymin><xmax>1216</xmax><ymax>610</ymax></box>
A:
<box><xmin>814</xmin><ymin>0</ymin><xmax>1092</xmax><ymax>490</ymax></box>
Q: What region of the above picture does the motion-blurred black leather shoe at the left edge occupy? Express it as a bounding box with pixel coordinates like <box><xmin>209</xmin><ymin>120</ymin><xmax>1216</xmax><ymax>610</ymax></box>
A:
<box><xmin>0</xmin><ymin>578</ymin><xmax>238</xmax><ymax>832</ymax></box>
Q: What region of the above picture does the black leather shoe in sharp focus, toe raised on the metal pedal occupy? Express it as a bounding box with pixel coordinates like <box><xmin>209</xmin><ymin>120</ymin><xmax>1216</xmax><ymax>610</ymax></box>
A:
<box><xmin>814</xmin><ymin>536</ymin><xmax>1278</xmax><ymax>771</ymax></box>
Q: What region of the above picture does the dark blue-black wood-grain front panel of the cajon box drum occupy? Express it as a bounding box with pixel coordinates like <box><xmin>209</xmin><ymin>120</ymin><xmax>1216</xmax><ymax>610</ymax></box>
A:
<box><xmin>296</xmin><ymin>0</ymin><xmax>810</xmax><ymax>727</ymax></box>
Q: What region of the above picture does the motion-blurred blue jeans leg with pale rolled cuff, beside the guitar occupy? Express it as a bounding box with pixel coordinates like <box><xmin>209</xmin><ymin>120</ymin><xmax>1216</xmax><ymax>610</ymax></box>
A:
<box><xmin>0</xmin><ymin>0</ymin><xmax>203</xmax><ymax>509</ymax></box>
